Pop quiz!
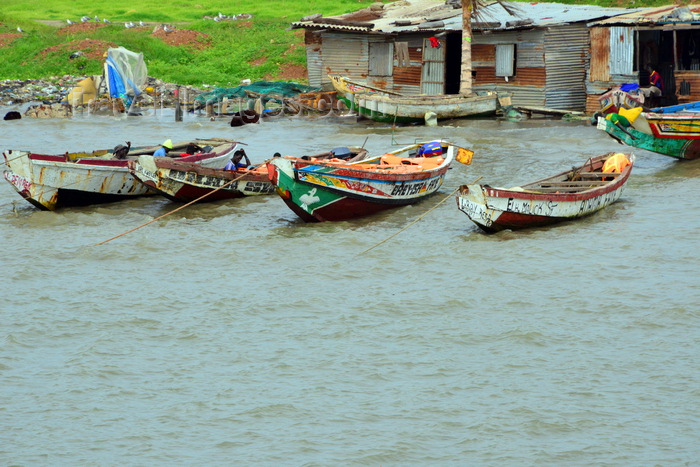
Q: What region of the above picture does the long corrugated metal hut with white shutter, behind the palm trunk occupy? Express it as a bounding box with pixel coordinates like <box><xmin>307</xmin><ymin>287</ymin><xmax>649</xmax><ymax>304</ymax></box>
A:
<box><xmin>292</xmin><ymin>0</ymin><xmax>629</xmax><ymax>110</ymax></box>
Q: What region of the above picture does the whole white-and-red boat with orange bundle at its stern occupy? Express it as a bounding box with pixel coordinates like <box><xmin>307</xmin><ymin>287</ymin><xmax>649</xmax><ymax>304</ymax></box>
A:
<box><xmin>457</xmin><ymin>153</ymin><xmax>634</xmax><ymax>232</ymax></box>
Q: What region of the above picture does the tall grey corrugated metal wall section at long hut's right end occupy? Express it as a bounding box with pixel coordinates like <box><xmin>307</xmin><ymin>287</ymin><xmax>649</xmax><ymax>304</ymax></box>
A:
<box><xmin>544</xmin><ymin>24</ymin><xmax>590</xmax><ymax>110</ymax></box>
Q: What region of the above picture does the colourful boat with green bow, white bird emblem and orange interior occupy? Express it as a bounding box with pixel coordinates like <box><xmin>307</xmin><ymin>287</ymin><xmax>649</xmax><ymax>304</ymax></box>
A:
<box><xmin>267</xmin><ymin>142</ymin><xmax>472</xmax><ymax>222</ymax></box>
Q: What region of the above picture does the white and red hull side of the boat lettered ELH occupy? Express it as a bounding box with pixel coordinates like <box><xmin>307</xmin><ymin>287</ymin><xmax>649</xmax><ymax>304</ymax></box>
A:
<box><xmin>457</xmin><ymin>154</ymin><xmax>632</xmax><ymax>232</ymax></box>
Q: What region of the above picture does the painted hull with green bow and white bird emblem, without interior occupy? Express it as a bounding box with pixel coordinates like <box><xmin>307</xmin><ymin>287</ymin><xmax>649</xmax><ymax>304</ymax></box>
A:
<box><xmin>268</xmin><ymin>146</ymin><xmax>455</xmax><ymax>222</ymax></box>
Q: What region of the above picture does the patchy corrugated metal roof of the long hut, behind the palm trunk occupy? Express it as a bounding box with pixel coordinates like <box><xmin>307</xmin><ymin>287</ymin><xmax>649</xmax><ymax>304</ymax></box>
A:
<box><xmin>292</xmin><ymin>0</ymin><xmax>639</xmax><ymax>34</ymax></box>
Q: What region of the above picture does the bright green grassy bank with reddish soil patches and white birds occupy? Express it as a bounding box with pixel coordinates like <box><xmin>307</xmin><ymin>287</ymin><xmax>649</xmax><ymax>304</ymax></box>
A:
<box><xmin>0</xmin><ymin>0</ymin><xmax>388</xmax><ymax>86</ymax></box>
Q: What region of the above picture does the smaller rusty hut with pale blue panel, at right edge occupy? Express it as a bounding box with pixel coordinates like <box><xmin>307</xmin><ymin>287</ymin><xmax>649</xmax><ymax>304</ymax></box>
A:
<box><xmin>586</xmin><ymin>5</ymin><xmax>700</xmax><ymax>112</ymax></box>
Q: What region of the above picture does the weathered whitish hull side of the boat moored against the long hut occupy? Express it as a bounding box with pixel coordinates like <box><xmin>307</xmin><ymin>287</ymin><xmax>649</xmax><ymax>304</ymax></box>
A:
<box><xmin>354</xmin><ymin>92</ymin><xmax>499</xmax><ymax>123</ymax></box>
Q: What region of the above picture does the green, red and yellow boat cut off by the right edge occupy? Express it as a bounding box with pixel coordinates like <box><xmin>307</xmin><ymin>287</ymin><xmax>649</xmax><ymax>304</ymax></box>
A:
<box><xmin>597</xmin><ymin>102</ymin><xmax>700</xmax><ymax>159</ymax></box>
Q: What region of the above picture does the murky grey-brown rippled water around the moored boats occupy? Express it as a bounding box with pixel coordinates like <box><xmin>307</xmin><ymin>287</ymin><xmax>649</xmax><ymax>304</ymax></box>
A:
<box><xmin>0</xmin><ymin>109</ymin><xmax>700</xmax><ymax>466</ymax></box>
